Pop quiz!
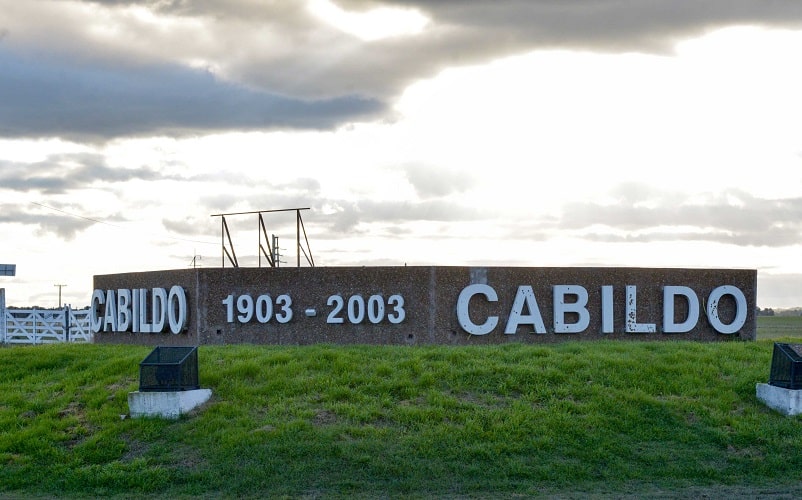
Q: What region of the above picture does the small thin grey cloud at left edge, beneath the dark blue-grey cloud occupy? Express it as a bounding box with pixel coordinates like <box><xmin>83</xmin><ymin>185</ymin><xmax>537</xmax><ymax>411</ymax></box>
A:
<box><xmin>0</xmin><ymin>153</ymin><xmax>177</xmax><ymax>195</ymax></box>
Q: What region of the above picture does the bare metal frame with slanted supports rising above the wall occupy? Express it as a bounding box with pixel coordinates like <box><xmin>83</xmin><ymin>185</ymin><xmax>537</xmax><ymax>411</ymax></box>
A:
<box><xmin>212</xmin><ymin>207</ymin><xmax>315</xmax><ymax>267</ymax></box>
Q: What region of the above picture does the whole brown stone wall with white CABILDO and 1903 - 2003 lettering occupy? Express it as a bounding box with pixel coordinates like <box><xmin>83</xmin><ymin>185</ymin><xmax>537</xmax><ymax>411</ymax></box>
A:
<box><xmin>92</xmin><ymin>266</ymin><xmax>757</xmax><ymax>345</ymax></box>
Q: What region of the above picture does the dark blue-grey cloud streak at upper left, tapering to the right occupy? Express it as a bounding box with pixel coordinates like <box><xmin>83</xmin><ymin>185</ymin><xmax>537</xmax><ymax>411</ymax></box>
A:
<box><xmin>0</xmin><ymin>50</ymin><xmax>381</xmax><ymax>140</ymax></box>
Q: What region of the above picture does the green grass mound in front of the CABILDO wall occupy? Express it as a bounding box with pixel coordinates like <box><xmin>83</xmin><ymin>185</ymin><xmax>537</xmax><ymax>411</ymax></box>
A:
<box><xmin>0</xmin><ymin>318</ymin><xmax>802</xmax><ymax>497</ymax></box>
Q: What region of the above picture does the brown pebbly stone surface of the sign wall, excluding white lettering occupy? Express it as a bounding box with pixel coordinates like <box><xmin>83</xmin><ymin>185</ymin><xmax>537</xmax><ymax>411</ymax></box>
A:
<box><xmin>94</xmin><ymin>267</ymin><xmax>757</xmax><ymax>345</ymax></box>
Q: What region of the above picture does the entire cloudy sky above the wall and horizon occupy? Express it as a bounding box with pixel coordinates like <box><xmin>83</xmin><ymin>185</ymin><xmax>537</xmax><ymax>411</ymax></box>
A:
<box><xmin>0</xmin><ymin>0</ymin><xmax>802</xmax><ymax>307</ymax></box>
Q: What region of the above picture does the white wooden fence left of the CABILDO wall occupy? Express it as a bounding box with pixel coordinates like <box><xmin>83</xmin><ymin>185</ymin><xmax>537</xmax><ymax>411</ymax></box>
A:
<box><xmin>0</xmin><ymin>289</ymin><xmax>92</xmax><ymax>344</ymax></box>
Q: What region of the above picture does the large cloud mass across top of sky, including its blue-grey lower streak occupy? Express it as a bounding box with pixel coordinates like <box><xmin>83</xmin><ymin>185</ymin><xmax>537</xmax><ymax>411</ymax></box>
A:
<box><xmin>0</xmin><ymin>0</ymin><xmax>802</xmax><ymax>139</ymax></box>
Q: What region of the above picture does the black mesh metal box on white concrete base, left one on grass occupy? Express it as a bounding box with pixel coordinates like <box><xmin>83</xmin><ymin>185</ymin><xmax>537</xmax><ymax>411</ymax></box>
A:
<box><xmin>139</xmin><ymin>346</ymin><xmax>200</xmax><ymax>392</ymax></box>
